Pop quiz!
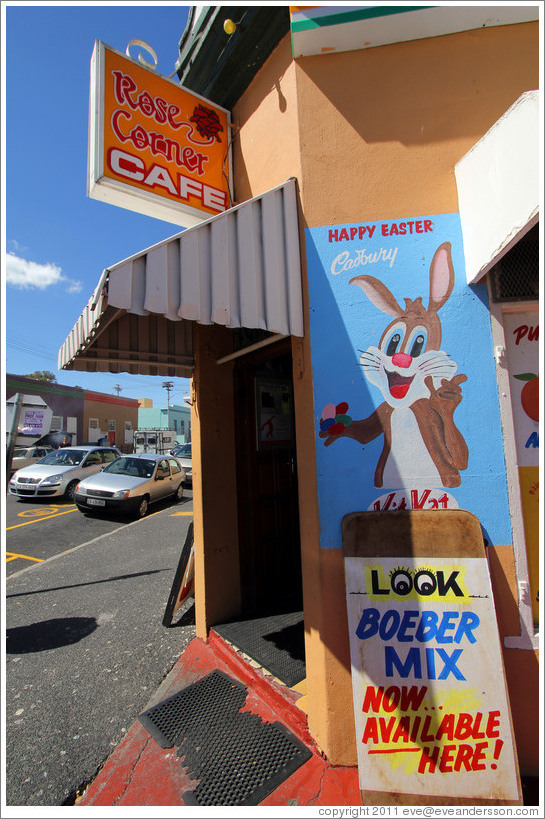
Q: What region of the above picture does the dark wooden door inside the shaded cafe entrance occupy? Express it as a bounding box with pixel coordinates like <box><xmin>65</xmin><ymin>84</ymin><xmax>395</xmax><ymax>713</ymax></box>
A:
<box><xmin>235</xmin><ymin>348</ymin><xmax>302</xmax><ymax>613</ymax></box>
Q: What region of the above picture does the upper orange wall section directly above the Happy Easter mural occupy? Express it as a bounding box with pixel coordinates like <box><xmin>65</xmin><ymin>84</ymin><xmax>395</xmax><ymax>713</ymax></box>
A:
<box><xmin>297</xmin><ymin>23</ymin><xmax>539</xmax><ymax>226</ymax></box>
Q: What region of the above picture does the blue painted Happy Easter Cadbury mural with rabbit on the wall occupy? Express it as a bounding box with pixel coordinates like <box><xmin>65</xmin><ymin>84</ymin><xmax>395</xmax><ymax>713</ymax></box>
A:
<box><xmin>306</xmin><ymin>213</ymin><xmax>512</xmax><ymax>548</ymax></box>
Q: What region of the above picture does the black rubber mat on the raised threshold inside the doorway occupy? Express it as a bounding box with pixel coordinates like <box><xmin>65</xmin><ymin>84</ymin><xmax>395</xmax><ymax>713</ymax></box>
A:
<box><xmin>214</xmin><ymin>611</ymin><xmax>306</xmax><ymax>688</ymax></box>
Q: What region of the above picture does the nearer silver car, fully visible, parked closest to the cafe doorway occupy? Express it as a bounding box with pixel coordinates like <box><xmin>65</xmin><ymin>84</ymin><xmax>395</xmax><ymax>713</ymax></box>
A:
<box><xmin>74</xmin><ymin>453</ymin><xmax>185</xmax><ymax>518</ymax></box>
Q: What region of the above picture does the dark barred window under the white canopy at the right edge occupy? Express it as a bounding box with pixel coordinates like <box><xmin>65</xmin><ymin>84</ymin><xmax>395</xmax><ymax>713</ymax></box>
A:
<box><xmin>490</xmin><ymin>223</ymin><xmax>539</xmax><ymax>302</ymax></box>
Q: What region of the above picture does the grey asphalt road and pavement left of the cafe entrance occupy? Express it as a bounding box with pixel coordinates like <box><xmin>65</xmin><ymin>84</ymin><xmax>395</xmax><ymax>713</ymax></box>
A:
<box><xmin>5</xmin><ymin>492</ymin><xmax>195</xmax><ymax>806</ymax></box>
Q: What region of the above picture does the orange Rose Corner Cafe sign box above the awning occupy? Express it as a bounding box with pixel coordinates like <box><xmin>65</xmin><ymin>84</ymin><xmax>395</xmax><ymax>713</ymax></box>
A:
<box><xmin>87</xmin><ymin>40</ymin><xmax>232</xmax><ymax>227</ymax></box>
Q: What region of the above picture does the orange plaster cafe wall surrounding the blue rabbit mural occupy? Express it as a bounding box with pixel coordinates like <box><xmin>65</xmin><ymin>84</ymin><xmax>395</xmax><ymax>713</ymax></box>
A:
<box><xmin>224</xmin><ymin>23</ymin><xmax>539</xmax><ymax>775</ymax></box>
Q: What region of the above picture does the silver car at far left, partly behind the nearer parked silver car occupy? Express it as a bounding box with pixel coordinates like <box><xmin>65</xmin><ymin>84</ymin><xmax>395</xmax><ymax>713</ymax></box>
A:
<box><xmin>9</xmin><ymin>446</ymin><xmax>121</xmax><ymax>500</ymax></box>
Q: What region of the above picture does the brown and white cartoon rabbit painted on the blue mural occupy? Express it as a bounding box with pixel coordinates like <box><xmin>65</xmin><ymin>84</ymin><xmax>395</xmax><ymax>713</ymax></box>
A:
<box><xmin>319</xmin><ymin>242</ymin><xmax>468</xmax><ymax>488</ymax></box>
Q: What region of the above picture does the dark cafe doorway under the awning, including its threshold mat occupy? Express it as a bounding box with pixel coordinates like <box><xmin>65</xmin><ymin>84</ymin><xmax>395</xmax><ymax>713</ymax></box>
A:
<box><xmin>214</xmin><ymin>339</ymin><xmax>306</xmax><ymax>687</ymax></box>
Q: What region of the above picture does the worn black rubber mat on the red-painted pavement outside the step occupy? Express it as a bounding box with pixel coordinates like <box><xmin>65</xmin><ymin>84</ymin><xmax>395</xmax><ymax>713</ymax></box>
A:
<box><xmin>139</xmin><ymin>670</ymin><xmax>312</xmax><ymax>807</ymax></box>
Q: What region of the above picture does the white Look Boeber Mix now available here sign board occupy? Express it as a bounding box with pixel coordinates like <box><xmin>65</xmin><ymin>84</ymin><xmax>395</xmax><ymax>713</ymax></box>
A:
<box><xmin>345</xmin><ymin>556</ymin><xmax>519</xmax><ymax>800</ymax></box>
